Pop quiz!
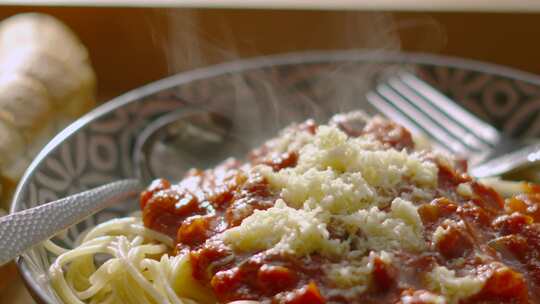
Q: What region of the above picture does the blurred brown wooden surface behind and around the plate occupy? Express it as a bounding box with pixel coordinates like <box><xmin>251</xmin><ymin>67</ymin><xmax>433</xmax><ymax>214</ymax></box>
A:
<box><xmin>0</xmin><ymin>7</ymin><xmax>540</xmax><ymax>304</ymax></box>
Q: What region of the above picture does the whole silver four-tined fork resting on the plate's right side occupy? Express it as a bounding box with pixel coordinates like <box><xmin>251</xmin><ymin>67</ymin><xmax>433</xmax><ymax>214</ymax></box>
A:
<box><xmin>366</xmin><ymin>72</ymin><xmax>540</xmax><ymax>178</ymax></box>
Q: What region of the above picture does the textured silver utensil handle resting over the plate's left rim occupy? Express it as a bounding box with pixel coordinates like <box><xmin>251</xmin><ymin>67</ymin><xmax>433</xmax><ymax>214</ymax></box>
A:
<box><xmin>0</xmin><ymin>179</ymin><xmax>142</xmax><ymax>265</ymax></box>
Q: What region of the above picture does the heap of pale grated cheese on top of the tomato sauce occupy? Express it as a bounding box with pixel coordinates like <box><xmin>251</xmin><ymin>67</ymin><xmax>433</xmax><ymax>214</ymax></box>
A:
<box><xmin>221</xmin><ymin>120</ymin><xmax>454</xmax><ymax>303</ymax></box>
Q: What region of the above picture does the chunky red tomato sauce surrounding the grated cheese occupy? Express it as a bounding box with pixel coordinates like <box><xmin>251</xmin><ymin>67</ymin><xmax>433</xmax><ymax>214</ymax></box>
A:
<box><xmin>140</xmin><ymin>120</ymin><xmax>540</xmax><ymax>304</ymax></box>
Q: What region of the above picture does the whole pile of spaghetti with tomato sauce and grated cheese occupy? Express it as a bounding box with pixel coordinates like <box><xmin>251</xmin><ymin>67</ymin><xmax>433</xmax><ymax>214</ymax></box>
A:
<box><xmin>45</xmin><ymin>113</ymin><xmax>540</xmax><ymax>304</ymax></box>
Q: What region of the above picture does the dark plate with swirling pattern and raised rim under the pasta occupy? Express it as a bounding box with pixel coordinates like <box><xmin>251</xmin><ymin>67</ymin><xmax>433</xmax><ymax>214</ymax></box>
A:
<box><xmin>12</xmin><ymin>51</ymin><xmax>540</xmax><ymax>304</ymax></box>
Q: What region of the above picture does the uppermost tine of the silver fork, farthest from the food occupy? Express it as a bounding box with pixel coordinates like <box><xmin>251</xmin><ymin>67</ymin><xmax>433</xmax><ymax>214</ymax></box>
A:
<box><xmin>399</xmin><ymin>73</ymin><xmax>500</xmax><ymax>146</ymax></box>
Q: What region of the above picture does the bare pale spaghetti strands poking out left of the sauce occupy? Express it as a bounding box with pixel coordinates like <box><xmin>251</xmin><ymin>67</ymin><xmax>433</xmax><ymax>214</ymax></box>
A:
<box><xmin>44</xmin><ymin>217</ymin><xmax>200</xmax><ymax>304</ymax></box>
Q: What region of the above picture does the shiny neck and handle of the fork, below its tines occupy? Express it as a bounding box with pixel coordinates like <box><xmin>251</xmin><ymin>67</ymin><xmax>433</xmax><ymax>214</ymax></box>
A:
<box><xmin>469</xmin><ymin>143</ymin><xmax>540</xmax><ymax>178</ymax></box>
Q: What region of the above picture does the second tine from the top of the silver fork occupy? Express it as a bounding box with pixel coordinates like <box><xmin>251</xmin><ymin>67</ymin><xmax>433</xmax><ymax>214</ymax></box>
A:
<box><xmin>387</xmin><ymin>77</ymin><xmax>491</xmax><ymax>152</ymax></box>
